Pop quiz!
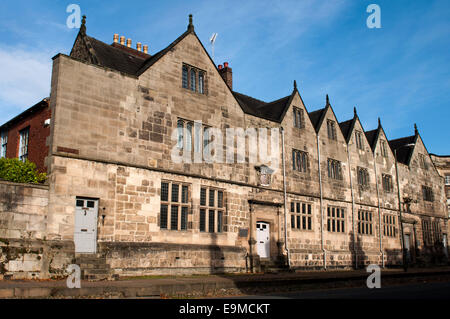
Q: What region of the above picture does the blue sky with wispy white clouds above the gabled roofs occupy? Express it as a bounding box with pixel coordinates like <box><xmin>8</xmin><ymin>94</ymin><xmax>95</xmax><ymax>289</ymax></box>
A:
<box><xmin>0</xmin><ymin>0</ymin><xmax>450</xmax><ymax>155</ymax></box>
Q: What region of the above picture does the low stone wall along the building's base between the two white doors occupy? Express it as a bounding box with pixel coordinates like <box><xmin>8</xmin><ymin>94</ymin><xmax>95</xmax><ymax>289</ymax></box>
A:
<box><xmin>99</xmin><ymin>242</ymin><xmax>246</xmax><ymax>276</ymax></box>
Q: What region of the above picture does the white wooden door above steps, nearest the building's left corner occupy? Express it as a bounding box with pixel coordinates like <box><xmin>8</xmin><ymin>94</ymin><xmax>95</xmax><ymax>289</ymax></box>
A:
<box><xmin>74</xmin><ymin>198</ymin><xmax>98</xmax><ymax>254</ymax></box>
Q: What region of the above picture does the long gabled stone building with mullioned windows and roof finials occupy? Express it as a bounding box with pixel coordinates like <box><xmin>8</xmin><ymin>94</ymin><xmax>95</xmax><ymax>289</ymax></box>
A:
<box><xmin>0</xmin><ymin>17</ymin><xmax>448</xmax><ymax>277</ymax></box>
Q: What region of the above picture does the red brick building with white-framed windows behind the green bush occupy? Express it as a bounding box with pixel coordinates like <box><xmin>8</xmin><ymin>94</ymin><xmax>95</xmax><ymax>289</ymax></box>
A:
<box><xmin>0</xmin><ymin>98</ymin><xmax>51</xmax><ymax>172</ymax></box>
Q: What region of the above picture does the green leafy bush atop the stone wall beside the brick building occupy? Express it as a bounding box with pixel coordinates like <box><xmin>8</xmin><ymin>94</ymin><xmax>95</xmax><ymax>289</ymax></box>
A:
<box><xmin>0</xmin><ymin>158</ymin><xmax>47</xmax><ymax>184</ymax></box>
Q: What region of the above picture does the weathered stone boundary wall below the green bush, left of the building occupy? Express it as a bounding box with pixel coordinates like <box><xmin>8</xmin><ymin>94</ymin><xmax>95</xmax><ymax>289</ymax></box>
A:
<box><xmin>0</xmin><ymin>181</ymin><xmax>74</xmax><ymax>279</ymax></box>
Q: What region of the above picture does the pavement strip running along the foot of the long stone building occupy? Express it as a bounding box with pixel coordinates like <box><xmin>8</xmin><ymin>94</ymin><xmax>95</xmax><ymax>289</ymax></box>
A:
<box><xmin>0</xmin><ymin>267</ymin><xmax>450</xmax><ymax>299</ymax></box>
